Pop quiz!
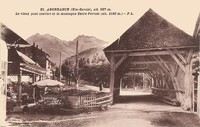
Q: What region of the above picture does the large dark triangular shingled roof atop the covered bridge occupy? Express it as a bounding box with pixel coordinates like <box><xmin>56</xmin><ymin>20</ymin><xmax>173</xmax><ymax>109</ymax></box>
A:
<box><xmin>104</xmin><ymin>9</ymin><xmax>198</xmax><ymax>52</ymax></box>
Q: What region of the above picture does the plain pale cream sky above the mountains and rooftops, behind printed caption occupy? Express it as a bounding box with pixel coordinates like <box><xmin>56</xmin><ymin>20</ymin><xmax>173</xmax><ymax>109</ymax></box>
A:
<box><xmin>0</xmin><ymin>0</ymin><xmax>200</xmax><ymax>43</ymax></box>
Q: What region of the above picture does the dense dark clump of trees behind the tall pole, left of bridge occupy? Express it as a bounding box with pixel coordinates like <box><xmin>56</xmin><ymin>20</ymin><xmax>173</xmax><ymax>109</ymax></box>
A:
<box><xmin>62</xmin><ymin>53</ymin><xmax>110</xmax><ymax>86</ymax></box>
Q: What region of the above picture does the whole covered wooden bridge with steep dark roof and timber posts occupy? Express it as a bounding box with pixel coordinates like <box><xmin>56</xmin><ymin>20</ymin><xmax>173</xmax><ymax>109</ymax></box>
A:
<box><xmin>104</xmin><ymin>9</ymin><xmax>199</xmax><ymax>110</ymax></box>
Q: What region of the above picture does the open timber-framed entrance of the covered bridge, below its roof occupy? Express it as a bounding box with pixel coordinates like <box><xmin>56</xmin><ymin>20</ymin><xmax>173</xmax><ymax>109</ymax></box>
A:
<box><xmin>104</xmin><ymin>47</ymin><xmax>197</xmax><ymax>111</ymax></box>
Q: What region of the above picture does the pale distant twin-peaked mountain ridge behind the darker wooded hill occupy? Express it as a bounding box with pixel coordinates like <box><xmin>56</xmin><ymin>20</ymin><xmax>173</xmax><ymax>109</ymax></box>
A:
<box><xmin>27</xmin><ymin>33</ymin><xmax>108</xmax><ymax>66</ymax></box>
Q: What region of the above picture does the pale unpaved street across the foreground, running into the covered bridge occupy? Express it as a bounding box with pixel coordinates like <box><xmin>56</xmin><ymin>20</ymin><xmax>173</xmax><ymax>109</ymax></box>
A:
<box><xmin>7</xmin><ymin>95</ymin><xmax>200</xmax><ymax>127</ymax></box>
